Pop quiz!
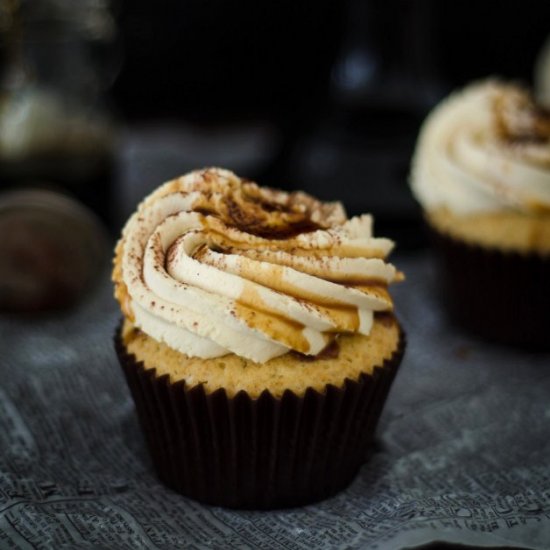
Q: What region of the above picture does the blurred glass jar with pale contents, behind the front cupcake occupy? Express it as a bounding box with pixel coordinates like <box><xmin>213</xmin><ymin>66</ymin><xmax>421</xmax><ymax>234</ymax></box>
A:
<box><xmin>0</xmin><ymin>0</ymin><xmax>121</xmax><ymax>226</ymax></box>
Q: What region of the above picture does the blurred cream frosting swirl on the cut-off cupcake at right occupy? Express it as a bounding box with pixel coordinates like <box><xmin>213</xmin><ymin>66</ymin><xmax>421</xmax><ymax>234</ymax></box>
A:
<box><xmin>411</xmin><ymin>80</ymin><xmax>550</xmax><ymax>214</ymax></box>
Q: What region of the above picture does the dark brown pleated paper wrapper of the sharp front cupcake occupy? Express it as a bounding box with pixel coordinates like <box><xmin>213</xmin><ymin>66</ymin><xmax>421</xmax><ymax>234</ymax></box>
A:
<box><xmin>115</xmin><ymin>329</ymin><xmax>405</xmax><ymax>509</ymax></box>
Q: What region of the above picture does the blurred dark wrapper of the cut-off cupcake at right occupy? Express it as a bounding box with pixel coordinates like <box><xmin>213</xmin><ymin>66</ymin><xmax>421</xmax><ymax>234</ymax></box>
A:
<box><xmin>428</xmin><ymin>227</ymin><xmax>550</xmax><ymax>349</ymax></box>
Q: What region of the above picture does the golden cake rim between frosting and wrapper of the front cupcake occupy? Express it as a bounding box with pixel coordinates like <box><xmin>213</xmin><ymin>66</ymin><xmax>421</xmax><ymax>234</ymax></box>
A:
<box><xmin>122</xmin><ymin>314</ymin><xmax>400</xmax><ymax>397</ymax></box>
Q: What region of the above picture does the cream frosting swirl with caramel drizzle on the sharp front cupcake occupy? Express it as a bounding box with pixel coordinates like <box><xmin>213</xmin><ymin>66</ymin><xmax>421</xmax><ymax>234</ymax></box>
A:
<box><xmin>113</xmin><ymin>168</ymin><xmax>401</xmax><ymax>362</ymax></box>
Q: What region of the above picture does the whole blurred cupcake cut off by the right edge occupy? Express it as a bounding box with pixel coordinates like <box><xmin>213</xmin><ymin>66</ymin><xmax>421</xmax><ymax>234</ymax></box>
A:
<box><xmin>411</xmin><ymin>80</ymin><xmax>550</xmax><ymax>349</ymax></box>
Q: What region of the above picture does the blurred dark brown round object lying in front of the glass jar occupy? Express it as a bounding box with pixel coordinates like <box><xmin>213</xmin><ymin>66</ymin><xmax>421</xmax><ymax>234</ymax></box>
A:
<box><xmin>0</xmin><ymin>189</ymin><xmax>108</xmax><ymax>312</ymax></box>
